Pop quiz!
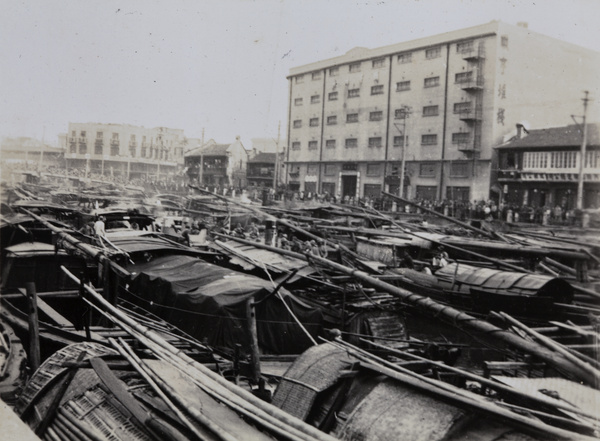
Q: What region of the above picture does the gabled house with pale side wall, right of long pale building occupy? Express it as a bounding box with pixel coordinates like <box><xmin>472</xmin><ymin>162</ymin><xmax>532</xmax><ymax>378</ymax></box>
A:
<box><xmin>185</xmin><ymin>137</ymin><xmax>249</xmax><ymax>188</ymax></box>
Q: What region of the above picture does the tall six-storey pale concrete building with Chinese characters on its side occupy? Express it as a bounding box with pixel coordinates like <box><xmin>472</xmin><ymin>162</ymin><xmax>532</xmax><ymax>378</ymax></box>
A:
<box><xmin>286</xmin><ymin>21</ymin><xmax>600</xmax><ymax>200</ymax></box>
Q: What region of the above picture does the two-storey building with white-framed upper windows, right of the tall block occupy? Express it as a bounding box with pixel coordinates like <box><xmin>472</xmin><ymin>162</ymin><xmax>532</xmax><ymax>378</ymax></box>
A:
<box><xmin>496</xmin><ymin>124</ymin><xmax>600</xmax><ymax>210</ymax></box>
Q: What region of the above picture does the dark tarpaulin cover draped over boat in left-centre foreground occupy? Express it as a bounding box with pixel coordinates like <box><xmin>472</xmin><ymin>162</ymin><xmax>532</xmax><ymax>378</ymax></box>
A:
<box><xmin>129</xmin><ymin>255</ymin><xmax>323</xmax><ymax>354</ymax></box>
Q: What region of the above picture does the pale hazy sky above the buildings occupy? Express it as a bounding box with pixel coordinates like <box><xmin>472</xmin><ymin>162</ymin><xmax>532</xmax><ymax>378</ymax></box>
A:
<box><xmin>0</xmin><ymin>0</ymin><xmax>600</xmax><ymax>148</ymax></box>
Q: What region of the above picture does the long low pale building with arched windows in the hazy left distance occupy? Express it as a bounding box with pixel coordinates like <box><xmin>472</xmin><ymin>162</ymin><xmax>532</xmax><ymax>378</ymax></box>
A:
<box><xmin>65</xmin><ymin>123</ymin><xmax>187</xmax><ymax>181</ymax></box>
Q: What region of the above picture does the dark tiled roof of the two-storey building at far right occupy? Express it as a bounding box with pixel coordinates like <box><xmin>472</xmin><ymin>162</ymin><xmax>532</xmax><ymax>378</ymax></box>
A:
<box><xmin>497</xmin><ymin>124</ymin><xmax>600</xmax><ymax>149</ymax></box>
